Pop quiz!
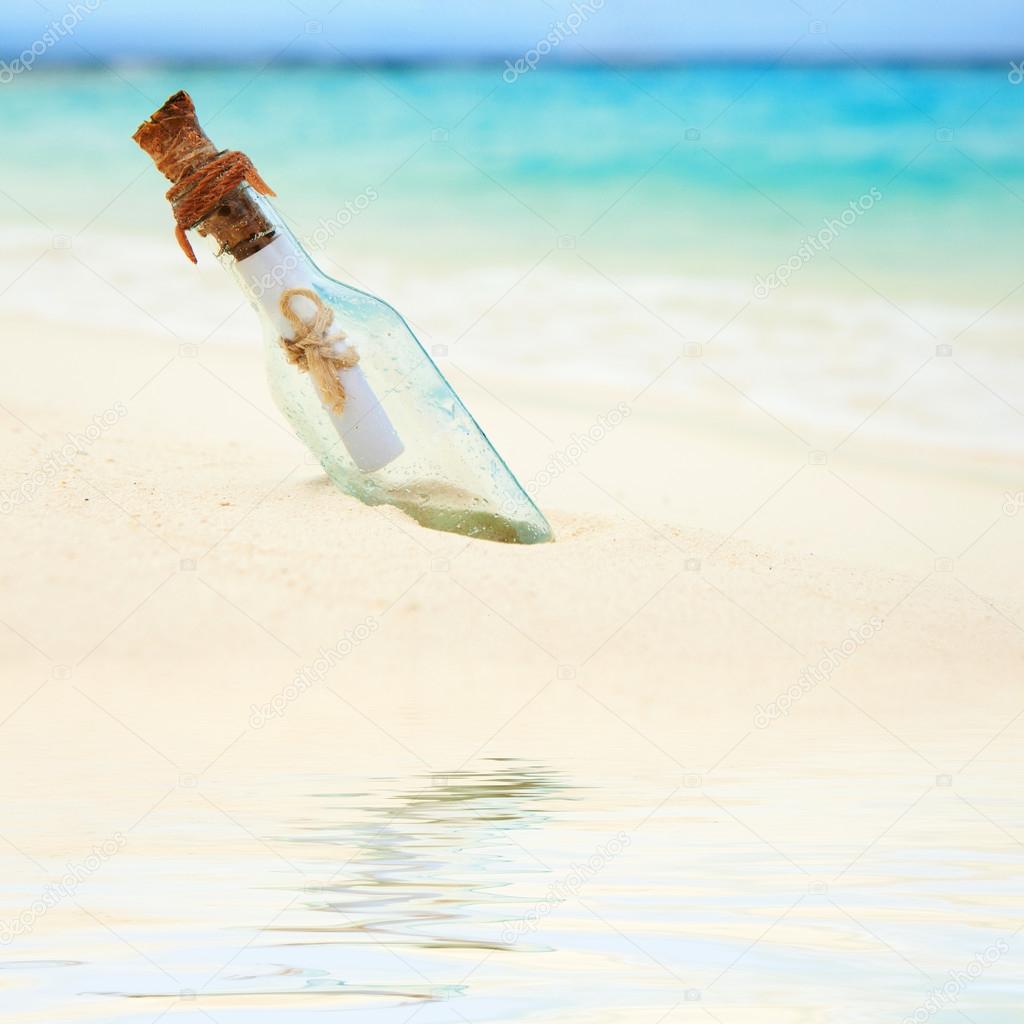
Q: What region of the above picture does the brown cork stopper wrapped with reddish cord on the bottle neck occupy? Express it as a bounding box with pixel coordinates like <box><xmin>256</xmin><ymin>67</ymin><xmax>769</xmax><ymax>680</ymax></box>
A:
<box><xmin>132</xmin><ymin>90</ymin><xmax>274</xmax><ymax>262</ymax></box>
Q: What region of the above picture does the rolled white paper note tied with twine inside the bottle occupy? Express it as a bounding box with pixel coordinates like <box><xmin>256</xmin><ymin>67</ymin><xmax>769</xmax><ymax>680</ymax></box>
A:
<box><xmin>238</xmin><ymin>234</ymin><xmax>406</xmax><ymax>473</ymax></box>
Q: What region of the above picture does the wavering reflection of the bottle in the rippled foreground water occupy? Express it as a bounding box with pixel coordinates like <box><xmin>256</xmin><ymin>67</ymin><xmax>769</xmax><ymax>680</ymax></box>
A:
<box><xmin>73</xmin><ymin>760</ymin><xmax>574</xmax><ymax>1011</ymax></box>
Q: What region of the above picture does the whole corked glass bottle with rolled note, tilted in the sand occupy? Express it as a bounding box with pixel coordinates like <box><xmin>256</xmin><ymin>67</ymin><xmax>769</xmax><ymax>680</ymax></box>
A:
<box><xmin>132</xmin><ymin>90</ymin><xmax>552</xmax><ymax>544</ymax></box>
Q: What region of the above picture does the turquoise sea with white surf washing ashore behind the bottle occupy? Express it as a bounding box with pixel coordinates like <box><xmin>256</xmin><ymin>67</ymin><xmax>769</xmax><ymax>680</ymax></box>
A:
<box><xmin>0</xmin><ymin>63</ymin><xmax>1024</xmax><ymax>452</ymax></box>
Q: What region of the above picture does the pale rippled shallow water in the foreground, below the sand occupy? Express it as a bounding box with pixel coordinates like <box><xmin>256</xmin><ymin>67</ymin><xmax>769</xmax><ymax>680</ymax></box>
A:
<box><xmin>0</xmin><ymin>760</ymin><xmax>1024</xmax><ymax>1024</ymax></box>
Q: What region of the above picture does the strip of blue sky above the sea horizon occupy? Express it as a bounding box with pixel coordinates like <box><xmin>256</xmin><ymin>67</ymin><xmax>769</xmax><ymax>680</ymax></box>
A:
<box><xmin>0</xmin><ymin>0</ymin><xmax>1024</xmax><ymax>62</ymax></box>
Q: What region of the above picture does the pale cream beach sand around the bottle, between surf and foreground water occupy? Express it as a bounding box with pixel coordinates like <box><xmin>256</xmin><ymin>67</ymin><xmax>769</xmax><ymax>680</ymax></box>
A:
<box><xmin>0</xmin><ymin>312</ymin><xmax>1024</xmax><ymax>782</ymax></box>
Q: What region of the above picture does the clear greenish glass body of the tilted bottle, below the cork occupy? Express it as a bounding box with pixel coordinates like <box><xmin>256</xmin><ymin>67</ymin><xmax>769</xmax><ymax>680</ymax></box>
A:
<box><xmin>229</xmin><ymin>194</ymin><xmax>552</xmax><ymax>544</ymax></box>
